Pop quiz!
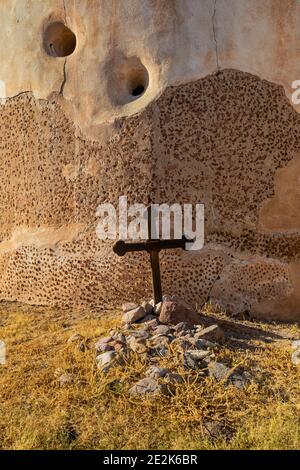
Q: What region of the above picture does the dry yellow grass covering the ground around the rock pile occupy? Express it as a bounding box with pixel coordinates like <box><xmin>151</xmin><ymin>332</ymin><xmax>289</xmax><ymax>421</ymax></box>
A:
<box><xmin>0</xmin><ymin>304</ymin><xmax>300</xmax><ymax>450</ymax></box>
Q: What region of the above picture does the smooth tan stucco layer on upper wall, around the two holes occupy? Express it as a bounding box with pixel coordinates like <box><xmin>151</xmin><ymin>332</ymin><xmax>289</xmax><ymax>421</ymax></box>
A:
<box><xmin>0</xmin><ymin>0</ymin><xmax>300</xmax><ymax>137</ymax></box>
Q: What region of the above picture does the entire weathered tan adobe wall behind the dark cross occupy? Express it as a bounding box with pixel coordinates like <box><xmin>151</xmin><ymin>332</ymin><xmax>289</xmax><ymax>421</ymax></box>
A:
<box><xmin>0</xmin><ymin>0</ymin><xmax>300</xmax><ymax>320</ymax></box>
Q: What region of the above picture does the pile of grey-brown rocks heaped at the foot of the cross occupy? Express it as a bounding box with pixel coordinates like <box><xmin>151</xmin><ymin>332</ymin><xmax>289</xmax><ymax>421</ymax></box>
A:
<box><xmin>91</xmin><ymin>296</ymin><xmax>251</xmax><ymax>395</ymax></box>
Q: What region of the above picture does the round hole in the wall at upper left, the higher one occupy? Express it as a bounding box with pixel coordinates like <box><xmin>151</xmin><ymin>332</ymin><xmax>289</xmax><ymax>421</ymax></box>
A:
<box><xmin>44</xmin><ymin>21</ymin><xmax>77</xmax><ymax>57</ymax></box>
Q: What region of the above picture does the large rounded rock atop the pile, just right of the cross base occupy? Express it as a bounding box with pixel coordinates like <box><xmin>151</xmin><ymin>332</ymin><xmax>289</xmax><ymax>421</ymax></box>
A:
<box><xmin>159</xmin><ymin>295</ymin><xmax>200</xmax><ymax>325</ymax></box>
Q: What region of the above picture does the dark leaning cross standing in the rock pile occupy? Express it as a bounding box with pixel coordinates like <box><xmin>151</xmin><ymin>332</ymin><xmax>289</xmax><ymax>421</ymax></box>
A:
<box><xmin>113</xmin><ymin>207</ymin><xmax>193</xmax><ymax>304</ymax></box>
